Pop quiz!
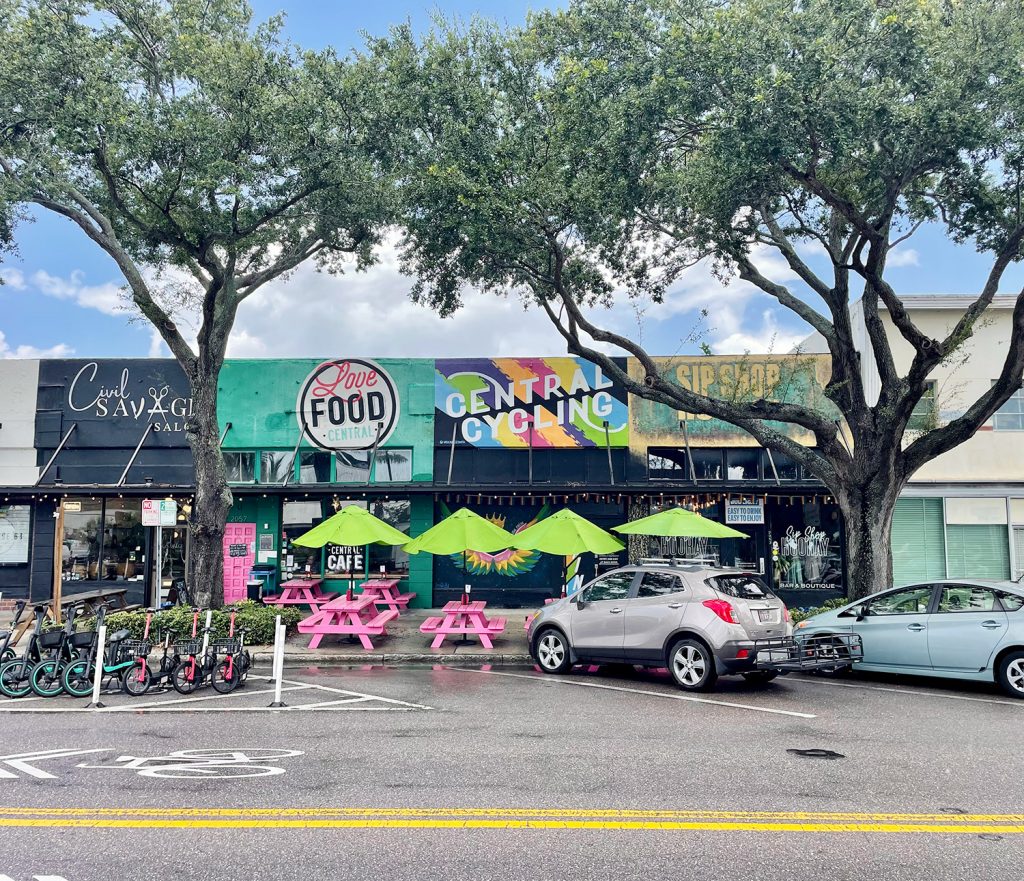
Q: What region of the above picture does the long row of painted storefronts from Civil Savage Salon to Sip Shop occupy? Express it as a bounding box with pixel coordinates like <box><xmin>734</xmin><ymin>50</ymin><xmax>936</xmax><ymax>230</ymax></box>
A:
<box><xmin>0</xmin><ymin>358</ymin><xmax>844</xmax><ymax>607</ymax></box>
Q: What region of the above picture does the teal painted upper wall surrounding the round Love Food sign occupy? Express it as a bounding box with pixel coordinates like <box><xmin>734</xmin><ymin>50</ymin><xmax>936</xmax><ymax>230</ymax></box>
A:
<box><xmin>217</xmin><ymin>359</ymin><xmax>434</xmax><ymax>481</ymax></box>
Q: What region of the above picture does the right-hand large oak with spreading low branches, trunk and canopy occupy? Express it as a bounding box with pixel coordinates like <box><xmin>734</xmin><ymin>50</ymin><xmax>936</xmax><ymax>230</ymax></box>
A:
<box><xmin>376</xmin><ymin>0</ymin><xmax>1024</xmax><ymax>596</ymax></box>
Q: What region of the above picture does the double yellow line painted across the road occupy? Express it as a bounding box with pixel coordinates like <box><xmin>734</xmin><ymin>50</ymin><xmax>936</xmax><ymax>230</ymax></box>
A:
<box><xmin>0</xmin><ymin>807</ymin><xmax>1024</xmax><ymax>835</ymax></box>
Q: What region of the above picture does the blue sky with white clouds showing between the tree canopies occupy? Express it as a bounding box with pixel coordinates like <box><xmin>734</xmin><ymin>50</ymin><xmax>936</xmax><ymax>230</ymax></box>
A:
<box><xmin>0</xmin><ymin>0</ymin><xmax>1024</xmax><ymax>358</ymax></box>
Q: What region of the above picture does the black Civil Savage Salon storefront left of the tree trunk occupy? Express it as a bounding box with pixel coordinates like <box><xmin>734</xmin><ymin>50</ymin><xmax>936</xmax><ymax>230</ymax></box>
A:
<box><xmin>22</xmin><ymin>359</ymin><xmax>195</xmax><ymax>603</ymax></box>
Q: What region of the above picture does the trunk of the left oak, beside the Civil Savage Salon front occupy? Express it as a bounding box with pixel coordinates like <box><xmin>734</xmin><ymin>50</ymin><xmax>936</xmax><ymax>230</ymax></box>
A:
<box><xmin>188</xmin><ymin>372</ymin><xmax>231</xmax><ymax>609</ymax></box>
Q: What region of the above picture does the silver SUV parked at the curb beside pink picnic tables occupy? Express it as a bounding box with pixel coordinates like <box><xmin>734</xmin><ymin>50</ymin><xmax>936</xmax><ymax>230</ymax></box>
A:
<box><xmin>527</xmin><ymin>562</ymin><xmax>793</xmax><ymax>691</ymax></box>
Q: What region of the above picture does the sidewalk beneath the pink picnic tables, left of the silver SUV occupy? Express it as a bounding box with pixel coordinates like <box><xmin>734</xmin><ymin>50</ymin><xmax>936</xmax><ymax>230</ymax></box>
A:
<box><xmin>252</xmin><ymin>606</ymin><xmax>532</xmax><ymax>665</ymax></box>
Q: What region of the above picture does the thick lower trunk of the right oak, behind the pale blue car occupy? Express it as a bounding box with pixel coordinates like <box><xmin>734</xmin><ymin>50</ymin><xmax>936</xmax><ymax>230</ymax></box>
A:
<box><xmin>837</xmin><ymin>472</ymin><xmax>902</xmax><ymax>599</ymax></box>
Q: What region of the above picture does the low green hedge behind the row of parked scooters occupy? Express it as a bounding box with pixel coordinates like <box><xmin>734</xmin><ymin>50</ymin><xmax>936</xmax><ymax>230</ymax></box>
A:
<box><xmin>76</xmin><ymin>599</ymin><xmax>307</xmax><ymax>645</ymax></box>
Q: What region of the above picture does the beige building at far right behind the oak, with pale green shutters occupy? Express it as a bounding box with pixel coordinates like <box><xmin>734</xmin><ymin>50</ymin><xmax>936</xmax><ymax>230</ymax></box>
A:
<box><xmin>802</xmin><ymin>295</ymin><xmax>1024</xmax><ymax>583</ymax></box>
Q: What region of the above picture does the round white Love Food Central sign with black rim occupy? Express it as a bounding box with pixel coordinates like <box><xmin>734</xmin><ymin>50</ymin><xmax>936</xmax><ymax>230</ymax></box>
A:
<box><xmin>295</xmin><ymin>358</ymin><xmax>400</xmax><ymax>450</ymax></box>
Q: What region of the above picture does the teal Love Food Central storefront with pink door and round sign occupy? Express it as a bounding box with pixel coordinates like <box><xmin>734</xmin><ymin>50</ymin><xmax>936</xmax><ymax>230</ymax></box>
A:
<box><xmin>218</xmin><ymin>359</ymin><xmax>434</xmax><ymax>606</ymax></box>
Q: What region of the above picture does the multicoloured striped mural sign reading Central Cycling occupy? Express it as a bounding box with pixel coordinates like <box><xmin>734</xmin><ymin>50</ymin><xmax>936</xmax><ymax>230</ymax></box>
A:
<box><xmin>434</xmin><ymin>358</ymin><xmax>629</xmax><ymax>448</ymax></box>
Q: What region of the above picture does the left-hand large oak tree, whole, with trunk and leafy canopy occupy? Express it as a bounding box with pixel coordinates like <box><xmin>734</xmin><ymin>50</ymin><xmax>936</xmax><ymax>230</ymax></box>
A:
<box><xmin>0</xmin><ymin>0</ymin><xmax>387</xmax><ymax>604</ymax></box>
